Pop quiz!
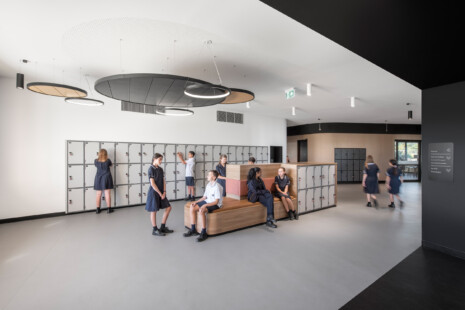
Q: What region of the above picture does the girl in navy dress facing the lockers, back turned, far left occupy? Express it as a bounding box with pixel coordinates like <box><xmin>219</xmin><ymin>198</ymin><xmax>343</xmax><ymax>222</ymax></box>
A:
<box><xmin>94</xmin><ymin>149</ymin><xmax>113</xmax><ymax>214</ymax></box>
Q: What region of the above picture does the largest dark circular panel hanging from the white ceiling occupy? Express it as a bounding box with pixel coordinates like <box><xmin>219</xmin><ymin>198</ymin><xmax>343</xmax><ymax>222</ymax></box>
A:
<box><xmin>95</xmin><ymin>73</ymin><xmax>225</xmax><ymax>108</ymax></box>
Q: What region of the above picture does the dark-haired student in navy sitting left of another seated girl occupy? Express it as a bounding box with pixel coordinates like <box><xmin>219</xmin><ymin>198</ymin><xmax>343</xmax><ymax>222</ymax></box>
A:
<box><xmin>247</xmin><ymin>167</ymin><xmax>278</xmax><ymax>228</ymax></box>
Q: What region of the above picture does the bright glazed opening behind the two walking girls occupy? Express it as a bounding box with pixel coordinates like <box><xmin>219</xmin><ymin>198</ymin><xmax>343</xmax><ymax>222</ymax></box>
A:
<box><xmin>396</xmin><ymin>140</ymin><xmax>421</xmax><ymax>182</ymax></box>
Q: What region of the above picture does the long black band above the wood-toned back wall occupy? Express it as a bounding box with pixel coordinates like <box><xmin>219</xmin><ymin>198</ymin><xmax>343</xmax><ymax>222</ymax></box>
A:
<box><xmin>287</xmin><ymin>123</ymin><xmax>421</xmax><ymax>137</ymax></box>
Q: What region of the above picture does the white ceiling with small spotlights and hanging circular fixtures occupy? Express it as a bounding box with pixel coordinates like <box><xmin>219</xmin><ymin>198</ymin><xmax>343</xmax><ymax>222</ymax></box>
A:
<box><xmin>0</xmin><ymin>0</ymin><xmax>421</xmax><ymax>125</ymax></box>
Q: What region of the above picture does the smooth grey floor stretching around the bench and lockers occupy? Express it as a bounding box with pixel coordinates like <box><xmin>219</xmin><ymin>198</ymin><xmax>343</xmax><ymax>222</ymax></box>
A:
<box><xmin>0</xmin><ymin>183</ymin><xmax>421</xmax><ymax>310</ymax></box>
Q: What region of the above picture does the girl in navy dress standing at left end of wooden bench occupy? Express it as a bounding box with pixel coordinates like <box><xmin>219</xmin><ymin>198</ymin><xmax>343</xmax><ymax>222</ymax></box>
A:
<box><xmin>145</xmin><ymin>153</ymin><xmax>173</xmax><ymax>236</ymax></box>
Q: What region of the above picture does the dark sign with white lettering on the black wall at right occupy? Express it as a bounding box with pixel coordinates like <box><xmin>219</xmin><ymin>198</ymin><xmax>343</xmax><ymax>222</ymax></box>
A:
<box><xmin>428</xmin><ymin>143</ymin><xmax>454</xmax><ymax>182</ymax></box>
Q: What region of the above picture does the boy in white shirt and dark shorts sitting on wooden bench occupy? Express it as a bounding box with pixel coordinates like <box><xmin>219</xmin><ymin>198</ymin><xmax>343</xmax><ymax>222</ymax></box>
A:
<box><xmin>184</xmin><ymin>170</ymin><xmax>223</xmax><ymax>242</ymax></box>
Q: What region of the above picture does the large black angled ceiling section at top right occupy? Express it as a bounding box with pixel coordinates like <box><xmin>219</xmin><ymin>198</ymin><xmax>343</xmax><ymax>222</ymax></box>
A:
<box><xmin>262</xmin><ymin>0</ymin><xmax>465</xmax><ymax>89</ymax></box>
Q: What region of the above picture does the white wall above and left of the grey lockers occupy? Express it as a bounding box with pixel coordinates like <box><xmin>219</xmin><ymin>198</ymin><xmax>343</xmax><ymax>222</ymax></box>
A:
<box><xmin>0</xmin><ymin>79</ymin><xmax>286</xmax><ymax>219</ymax></box>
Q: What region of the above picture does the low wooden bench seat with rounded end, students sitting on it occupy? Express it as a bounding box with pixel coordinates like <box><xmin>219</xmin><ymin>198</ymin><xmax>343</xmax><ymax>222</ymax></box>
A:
<box><xmin>184</xmin><ymin>197</ymin><xmax>297</xmax><ymax>235</ymax></box>
